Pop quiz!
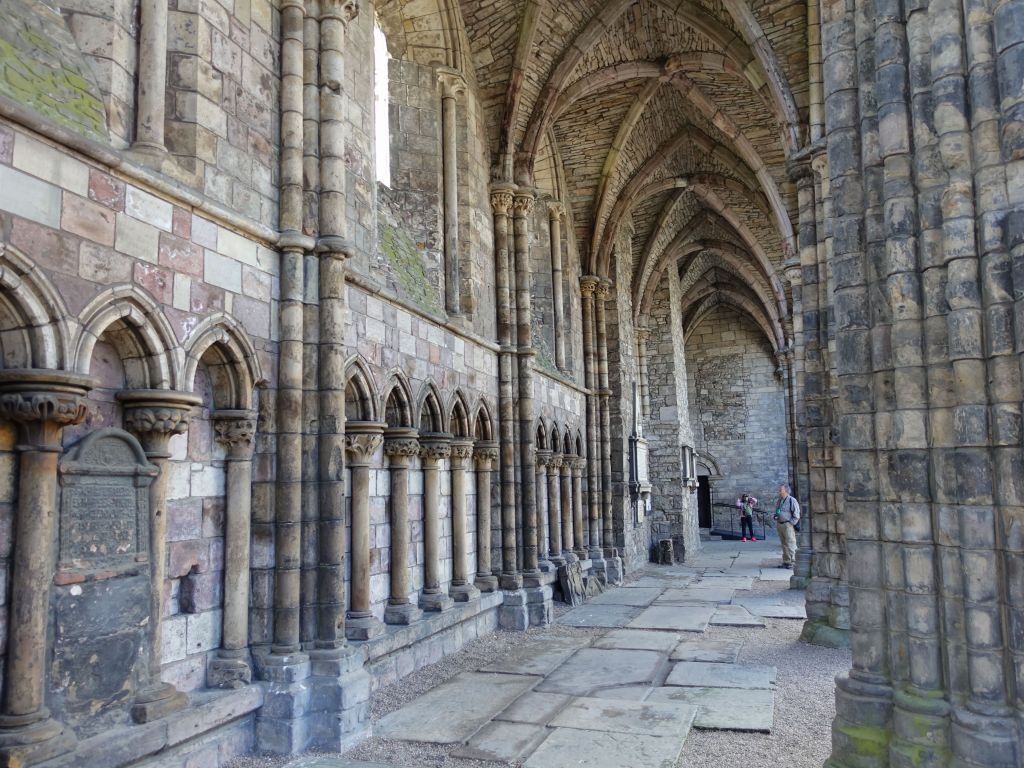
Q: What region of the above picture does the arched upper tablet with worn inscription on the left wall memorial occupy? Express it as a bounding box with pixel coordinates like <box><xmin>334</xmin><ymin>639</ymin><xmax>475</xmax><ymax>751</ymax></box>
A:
<box><xmin>60</xmin><ymin>429</ymin><xmax>157</xmax><ymax>569</ymax></box>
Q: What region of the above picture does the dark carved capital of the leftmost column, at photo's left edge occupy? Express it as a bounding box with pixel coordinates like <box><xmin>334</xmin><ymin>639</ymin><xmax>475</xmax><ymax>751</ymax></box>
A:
<box><xmin>0</xmin><ymin>370</ymin><xmax>95</xmax><ymax>450</ymax></box>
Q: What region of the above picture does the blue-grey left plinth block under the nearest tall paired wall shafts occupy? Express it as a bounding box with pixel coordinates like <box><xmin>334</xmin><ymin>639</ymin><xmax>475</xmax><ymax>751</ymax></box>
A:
<box><xmin>256</xmin><ymin>653</ymin><xmax>311</xmax><ymax>755</ymax></box>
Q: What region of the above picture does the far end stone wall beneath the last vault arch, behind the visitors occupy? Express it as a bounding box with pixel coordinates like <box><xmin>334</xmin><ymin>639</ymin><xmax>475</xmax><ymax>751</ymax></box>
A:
<box><xmin>686</xmin><ymin>306</ymin><xmax>791</xmax><ymax>507</ymax></box>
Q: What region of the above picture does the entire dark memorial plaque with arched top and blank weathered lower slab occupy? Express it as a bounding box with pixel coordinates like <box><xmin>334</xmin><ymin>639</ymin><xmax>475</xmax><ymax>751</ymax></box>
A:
<box><xmin>53</xmin><ymin>429</ymin><xmax>159</xmax><ymax>738</ymax></box>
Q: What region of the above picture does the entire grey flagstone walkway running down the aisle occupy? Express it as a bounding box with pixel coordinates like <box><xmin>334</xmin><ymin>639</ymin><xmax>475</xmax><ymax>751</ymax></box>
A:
<box><xmin>262</xmin><ymin>542</ymin><xmax>831</xmax><ymax>768</ymax></box>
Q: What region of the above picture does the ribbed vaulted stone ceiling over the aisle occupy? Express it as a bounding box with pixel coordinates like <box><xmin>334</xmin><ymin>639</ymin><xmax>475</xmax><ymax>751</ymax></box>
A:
<box><xmin>454</xmin><ymin>0</ymin><xmax>809</xmax><ymax>350</ymax></box>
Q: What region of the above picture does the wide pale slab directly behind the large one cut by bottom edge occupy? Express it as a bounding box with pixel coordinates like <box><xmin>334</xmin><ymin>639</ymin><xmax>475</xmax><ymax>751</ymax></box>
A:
<box><xmin>551</xmin><ymin>698</ymin><xmax>696</xmax><ymax>739</ymax></box>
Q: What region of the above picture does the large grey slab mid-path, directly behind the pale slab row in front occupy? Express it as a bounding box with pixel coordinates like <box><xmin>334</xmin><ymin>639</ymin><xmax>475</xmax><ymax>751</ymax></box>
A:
<box><xmin>537</xmin><ymin>648</ymin><xmax>666</xmax><ymax>696</ymax></box>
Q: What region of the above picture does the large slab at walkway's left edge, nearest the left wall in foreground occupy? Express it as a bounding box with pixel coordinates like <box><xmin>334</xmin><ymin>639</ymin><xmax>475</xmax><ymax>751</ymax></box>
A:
<box><xmin>374</xmin><ymin>672</ymin><xmax>538</xmax><ymax>744</ymax></box>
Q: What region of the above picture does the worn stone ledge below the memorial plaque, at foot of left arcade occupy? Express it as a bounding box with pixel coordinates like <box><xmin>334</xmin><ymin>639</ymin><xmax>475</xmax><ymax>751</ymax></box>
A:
<box><xmin>38</xmin><ymin>685</ymin><xmax>263</xmax><ymax>768</ymax></box>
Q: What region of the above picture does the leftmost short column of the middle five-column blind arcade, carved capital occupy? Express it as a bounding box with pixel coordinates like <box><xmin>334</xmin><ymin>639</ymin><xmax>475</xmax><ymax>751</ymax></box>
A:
<box><xmin>345</xmin><ymin>421</ymin><xmax>384</xmax><ymax>640</ymax></box>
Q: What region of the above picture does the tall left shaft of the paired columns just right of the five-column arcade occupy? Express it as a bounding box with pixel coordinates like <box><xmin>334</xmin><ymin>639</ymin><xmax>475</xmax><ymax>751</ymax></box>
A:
<box><xmin>490</xmin><ymin>187</ymin><xmax>522</xmax><ymax>590</ymax></box>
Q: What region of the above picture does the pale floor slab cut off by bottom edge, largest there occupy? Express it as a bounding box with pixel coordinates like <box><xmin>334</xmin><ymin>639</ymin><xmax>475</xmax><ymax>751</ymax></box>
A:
<box><xmin>524</xmin><ymin>728</ymin><xmax>683</xmax><ymax>768</ymax></box>
